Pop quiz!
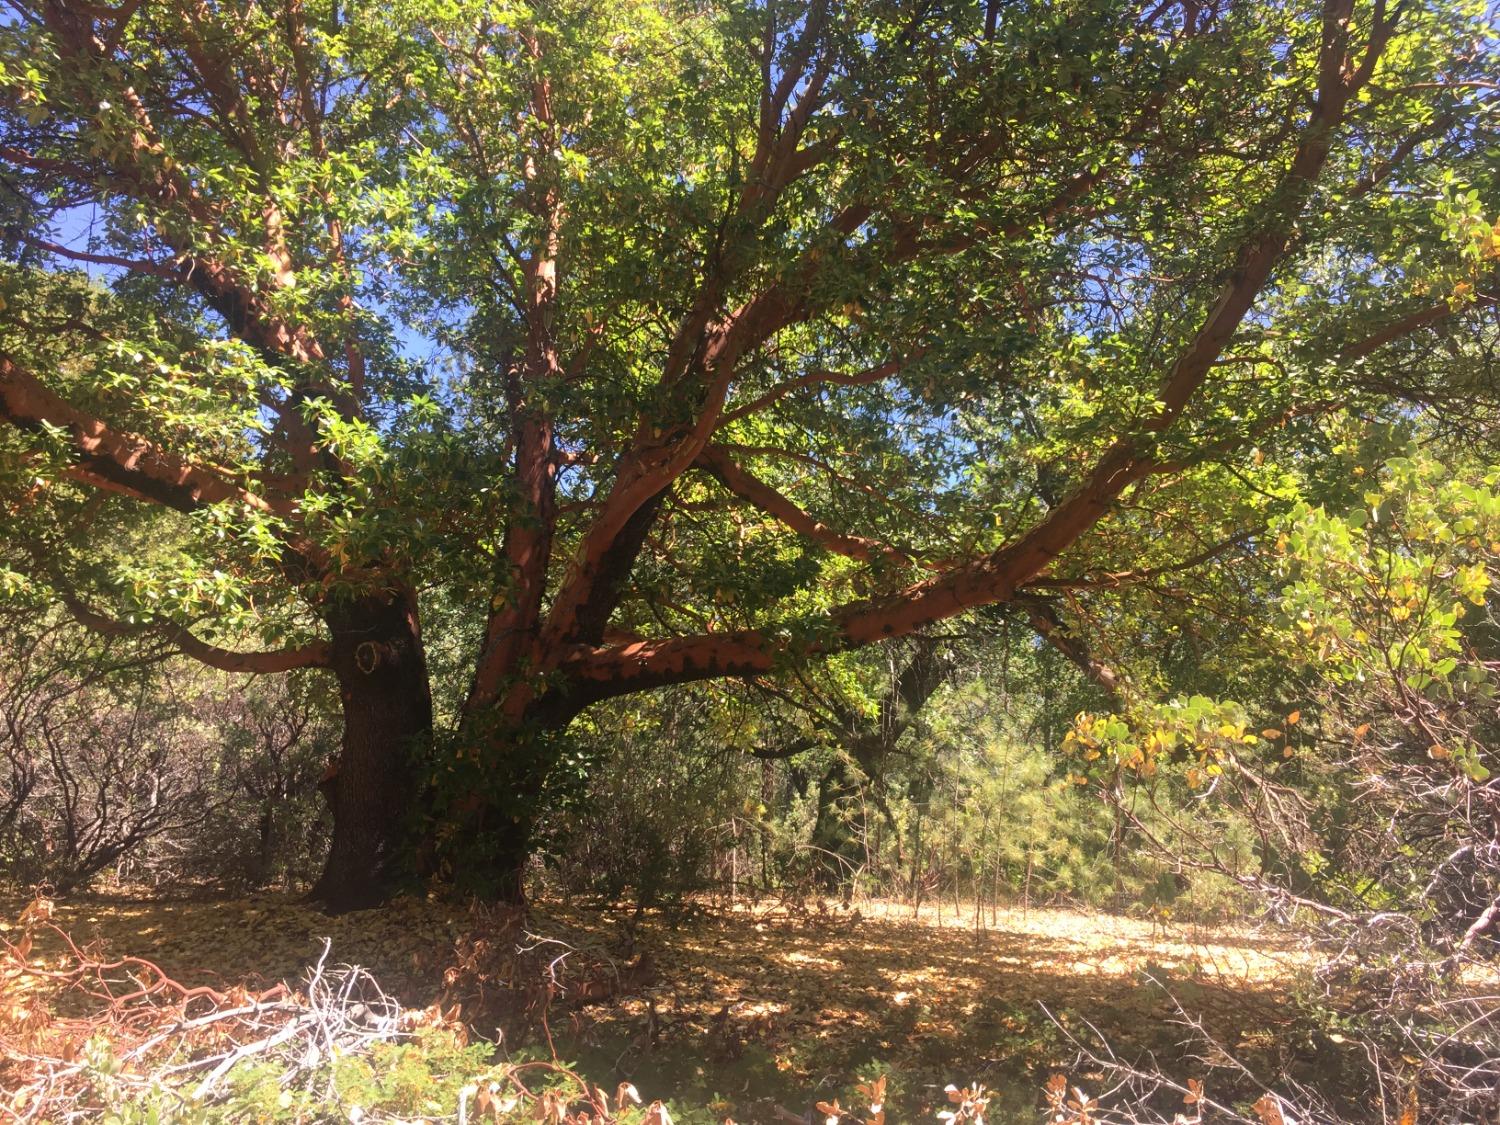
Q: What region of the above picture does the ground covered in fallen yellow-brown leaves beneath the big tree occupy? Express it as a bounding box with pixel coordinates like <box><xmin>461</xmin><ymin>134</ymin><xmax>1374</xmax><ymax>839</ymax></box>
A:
<box><xmin>0</xmin><ymin>893</ymin><xmax>1307</xmax><ymax>1121</ymax></box>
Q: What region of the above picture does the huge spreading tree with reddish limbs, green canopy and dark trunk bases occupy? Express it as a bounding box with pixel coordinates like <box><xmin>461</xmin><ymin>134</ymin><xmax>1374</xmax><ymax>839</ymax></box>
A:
<box><xmin>0</xmin><ymin>0</ymin><xmax>1497</xmax><ymax>908</ymax></box>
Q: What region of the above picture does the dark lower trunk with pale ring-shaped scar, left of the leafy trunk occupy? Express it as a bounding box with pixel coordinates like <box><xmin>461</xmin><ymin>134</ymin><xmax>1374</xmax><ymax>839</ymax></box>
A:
<box><xmin>312</xmin><ymin>591</ymin><xmax>432</xmax><ymax>911</ymax></box>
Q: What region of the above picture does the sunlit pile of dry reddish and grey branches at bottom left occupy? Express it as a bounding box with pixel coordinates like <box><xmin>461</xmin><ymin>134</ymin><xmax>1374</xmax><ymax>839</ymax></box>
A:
<box><xmin>0</xmin><ymin>899</ymin><xmax>671</xmax><ymax>1125</ymax></box>
